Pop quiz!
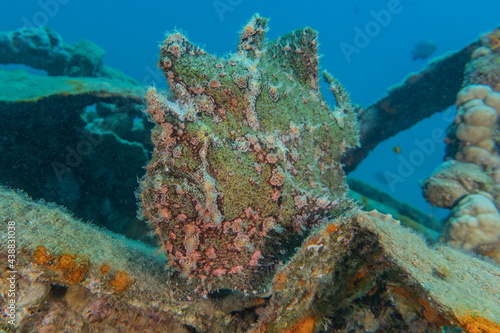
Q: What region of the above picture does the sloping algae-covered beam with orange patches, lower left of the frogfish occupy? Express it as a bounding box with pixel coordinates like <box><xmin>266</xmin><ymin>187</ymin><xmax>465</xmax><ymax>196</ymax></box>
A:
<box><xmin>0</xmin><ymin>187</ymin><xmax>246</xmax><ymax>332</ymax></box>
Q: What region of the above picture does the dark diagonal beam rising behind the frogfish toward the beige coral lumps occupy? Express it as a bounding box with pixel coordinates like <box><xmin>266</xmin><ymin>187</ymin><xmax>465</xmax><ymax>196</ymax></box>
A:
<box><xmin>343</xmin><ymin>35</ymin><xmax>481</xmax><ymax>173</ymax></box>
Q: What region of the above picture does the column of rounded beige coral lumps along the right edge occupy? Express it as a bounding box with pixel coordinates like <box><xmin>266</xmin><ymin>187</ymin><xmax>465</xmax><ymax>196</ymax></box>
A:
<box><xmin>423</xmin><ymin>29</ymin><xmax>500</xmax><ymax>263</ymax></box>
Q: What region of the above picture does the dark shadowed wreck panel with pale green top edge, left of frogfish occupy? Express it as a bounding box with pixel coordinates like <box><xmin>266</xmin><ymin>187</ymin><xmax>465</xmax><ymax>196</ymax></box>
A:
<box><xmin>0</xmin><ymin>70</ymin><xmax>154</xmax><ymax>243</ymax></box>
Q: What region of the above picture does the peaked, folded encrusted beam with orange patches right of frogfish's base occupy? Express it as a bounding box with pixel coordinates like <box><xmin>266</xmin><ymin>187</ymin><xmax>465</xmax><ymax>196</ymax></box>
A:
<box><xmin>252</xmin><ymin>210</ymin><xmax>500</xmax><ymax>333</ymax></box>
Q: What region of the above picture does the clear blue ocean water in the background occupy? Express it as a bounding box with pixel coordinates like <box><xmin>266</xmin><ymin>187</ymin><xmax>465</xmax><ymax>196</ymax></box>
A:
<box><xmin>0</xmin><ymin>0</ymin><xmax>500</xmax><ymax>213</ymax></box>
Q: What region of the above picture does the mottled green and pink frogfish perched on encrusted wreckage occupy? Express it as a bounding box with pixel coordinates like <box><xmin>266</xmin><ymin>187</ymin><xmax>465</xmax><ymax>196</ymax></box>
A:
<box><xmin>140</xmin><ymin>15</ymin><xmax>359</xmax><ymax>298</ymax></box>
